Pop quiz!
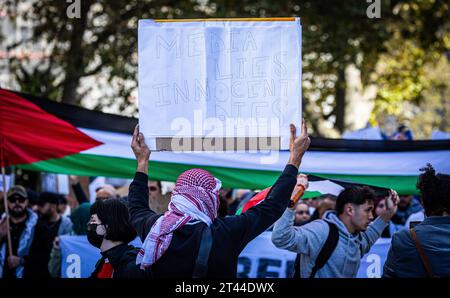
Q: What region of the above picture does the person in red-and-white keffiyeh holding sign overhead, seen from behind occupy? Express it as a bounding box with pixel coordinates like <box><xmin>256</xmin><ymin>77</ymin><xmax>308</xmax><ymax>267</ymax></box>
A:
<box><xmin>128</xmin><ymin>121</ymin><xmax>311</xmax><ymax>278</ymax></box>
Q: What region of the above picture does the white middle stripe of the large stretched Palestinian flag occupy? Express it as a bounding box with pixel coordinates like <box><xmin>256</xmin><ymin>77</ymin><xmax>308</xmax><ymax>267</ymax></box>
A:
<box><xmin>80</xmin><ymin>128</ymin><xmax>450</xmax><ymax>176</ymax></box>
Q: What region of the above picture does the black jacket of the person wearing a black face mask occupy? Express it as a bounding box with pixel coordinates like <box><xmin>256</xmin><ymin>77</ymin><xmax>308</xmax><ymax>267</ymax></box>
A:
<box><xmin>90</xmin><ymin>243</ymin><xmax>147</xmax><ymax>278</ymax></box>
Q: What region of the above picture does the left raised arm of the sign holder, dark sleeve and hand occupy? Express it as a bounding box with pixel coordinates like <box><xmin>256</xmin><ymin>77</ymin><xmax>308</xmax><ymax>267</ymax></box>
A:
<box><xmin>128</xmin><ymin>124</ymin><xmax>159</xmax><ymax>241</ymax></box>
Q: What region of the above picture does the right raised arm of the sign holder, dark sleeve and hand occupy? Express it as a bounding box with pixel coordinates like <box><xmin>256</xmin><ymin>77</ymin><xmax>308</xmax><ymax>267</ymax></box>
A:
<box><xmin>224</xmin><ymin>121</ymin><xmax>311</xmax><ymax>248</ymax></box>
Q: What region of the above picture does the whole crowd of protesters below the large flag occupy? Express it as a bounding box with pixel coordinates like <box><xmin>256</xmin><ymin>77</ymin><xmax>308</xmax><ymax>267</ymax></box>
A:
<box><xmin>0</xmin><ymin>122</ymin><xmax>450</xmax><ymax>279</ymax></box>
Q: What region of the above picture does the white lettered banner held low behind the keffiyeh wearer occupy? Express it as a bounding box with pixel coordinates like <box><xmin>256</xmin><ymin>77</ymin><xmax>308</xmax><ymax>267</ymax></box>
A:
<box><xmin>60</xmin><ymin>231</ymin><xmax>391</xmax><ymax>278</ymax></box>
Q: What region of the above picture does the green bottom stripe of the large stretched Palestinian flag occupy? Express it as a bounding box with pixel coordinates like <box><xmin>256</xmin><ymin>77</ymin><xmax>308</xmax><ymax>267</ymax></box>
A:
<box><xmin>18</xmin><ymin>154</ymin><xmax>417</xmax><ymax>197</ymax></box>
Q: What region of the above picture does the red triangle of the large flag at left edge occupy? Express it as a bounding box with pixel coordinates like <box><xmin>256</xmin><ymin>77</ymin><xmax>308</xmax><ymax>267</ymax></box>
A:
<box><xmin>0</xmin><ymin>89</ymin><xmax>103</xmax><ymax>166</ymax></box>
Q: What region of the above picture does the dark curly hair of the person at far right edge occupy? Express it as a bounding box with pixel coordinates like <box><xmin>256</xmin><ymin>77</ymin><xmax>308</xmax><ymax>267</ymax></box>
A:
<box><xmin>416</xmin><ymin>164</ymin><xmax>450</xmax><ymax>216</ymax></box>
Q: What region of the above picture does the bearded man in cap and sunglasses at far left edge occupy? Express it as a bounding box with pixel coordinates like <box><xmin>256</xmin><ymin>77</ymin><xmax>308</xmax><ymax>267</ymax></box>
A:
<box><xmin>0</xmin><ymin>185</ymin><xmax>38</xmax><ymax>278</ymax></box>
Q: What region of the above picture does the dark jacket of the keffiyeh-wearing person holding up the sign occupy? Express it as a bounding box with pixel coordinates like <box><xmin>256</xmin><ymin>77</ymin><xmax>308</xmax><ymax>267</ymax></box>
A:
<box><xmin>128</xmin><ymin>165</ymin><xmax>298</xmax><ymax>278</ymax></box>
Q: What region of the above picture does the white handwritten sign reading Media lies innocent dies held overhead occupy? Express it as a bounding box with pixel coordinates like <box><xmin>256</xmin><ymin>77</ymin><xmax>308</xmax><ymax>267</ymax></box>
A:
<box><xmin>138</xmin><ymin>18</ymin><xmax>301</xmax><ymax>151</ymax></box>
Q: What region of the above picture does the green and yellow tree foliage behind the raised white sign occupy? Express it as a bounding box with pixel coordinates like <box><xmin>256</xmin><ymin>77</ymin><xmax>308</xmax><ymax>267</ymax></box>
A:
<box><xmin>0</xmin><ymin>0</ymin><xmax>450</xmax><ymax>135</ymax></box>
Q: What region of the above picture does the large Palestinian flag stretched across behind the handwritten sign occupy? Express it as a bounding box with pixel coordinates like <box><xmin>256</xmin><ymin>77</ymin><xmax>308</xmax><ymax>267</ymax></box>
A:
<box><xmin>0</xmin><ymin>89</ymin><xmax>450</xmax><ymax>194</ymax></box>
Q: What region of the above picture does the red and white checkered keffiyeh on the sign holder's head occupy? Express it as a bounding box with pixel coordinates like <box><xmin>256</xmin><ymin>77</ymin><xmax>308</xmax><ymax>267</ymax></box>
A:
<box><xmin>136</xmin><ymin>169</ymin><xmax>222</xmax><ymax>269</ymax></box>
